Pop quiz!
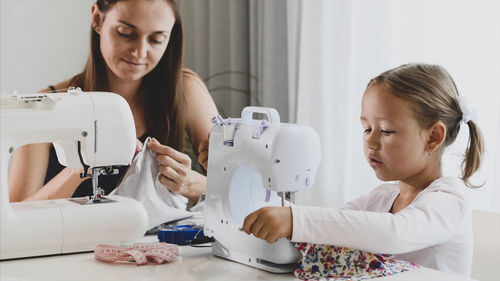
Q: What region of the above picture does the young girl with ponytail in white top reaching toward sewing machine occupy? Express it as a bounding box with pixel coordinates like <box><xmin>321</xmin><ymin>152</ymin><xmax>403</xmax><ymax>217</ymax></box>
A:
<box><xmin>243</xmin><ymin>64</ymin><xmax>483</xmax><ymax>276</ymax></box>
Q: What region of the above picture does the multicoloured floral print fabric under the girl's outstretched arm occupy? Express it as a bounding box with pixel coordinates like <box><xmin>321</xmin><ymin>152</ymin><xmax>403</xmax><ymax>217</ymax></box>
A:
<box><xmin>294</xmin><ymin>243</ymin><xmax>419</xmax><ymax>281</ymax></box>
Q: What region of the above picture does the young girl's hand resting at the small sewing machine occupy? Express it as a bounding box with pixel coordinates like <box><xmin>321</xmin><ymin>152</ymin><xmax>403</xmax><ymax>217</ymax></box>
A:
<box><xmin>243</xmin><ymin>207</ymin><xmax>293</xmax><ymax>243</ymax></box>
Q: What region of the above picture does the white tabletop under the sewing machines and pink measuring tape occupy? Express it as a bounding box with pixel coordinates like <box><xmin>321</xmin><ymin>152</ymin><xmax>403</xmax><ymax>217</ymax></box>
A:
<box><xmin>0</xmin><ymin>237</ymin><xmax>472</xmax><ymax>281</ymax></box>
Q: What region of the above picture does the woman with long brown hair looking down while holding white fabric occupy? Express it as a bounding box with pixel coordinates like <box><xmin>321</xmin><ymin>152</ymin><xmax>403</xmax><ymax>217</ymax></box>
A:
<box><xmin>9</xmin><ymin>0</ymin><xmax>217</xmax><ymax>202</ymax></box>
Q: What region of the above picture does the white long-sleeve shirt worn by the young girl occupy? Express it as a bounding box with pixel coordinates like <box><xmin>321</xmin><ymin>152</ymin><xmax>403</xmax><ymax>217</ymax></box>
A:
<box><xmin>291</xmin><ymin>178</ymin><xmax>472</xmax><ymax>276</ymax></box>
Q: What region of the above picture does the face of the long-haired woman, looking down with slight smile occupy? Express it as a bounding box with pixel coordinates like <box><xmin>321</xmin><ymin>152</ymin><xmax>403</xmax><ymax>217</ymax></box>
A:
<box><xmin>92</xmin><ymin>0</ymin><xmax>175</xmax><ymax>81</ymax></box>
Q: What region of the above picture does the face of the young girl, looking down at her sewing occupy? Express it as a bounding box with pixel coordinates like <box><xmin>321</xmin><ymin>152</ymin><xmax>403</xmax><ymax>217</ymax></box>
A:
<box><xmin>361</xmin><ymin>85</ymin><xmax>429</xmax><ymax>181</ymax></box>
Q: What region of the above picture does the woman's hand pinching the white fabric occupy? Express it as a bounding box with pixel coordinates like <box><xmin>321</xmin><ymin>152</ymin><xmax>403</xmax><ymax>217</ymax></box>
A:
<box><xmin>148</xmin><ymin>138</ymin><xmax>191</xmax><ymax>195</ymax></box>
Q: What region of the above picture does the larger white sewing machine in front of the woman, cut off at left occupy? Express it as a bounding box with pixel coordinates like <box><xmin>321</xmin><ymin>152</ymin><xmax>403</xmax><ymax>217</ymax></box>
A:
<box><xmin>0</xmin><ymin>88</ymin><xmax>148</xmax><ymax>260</ymax></box>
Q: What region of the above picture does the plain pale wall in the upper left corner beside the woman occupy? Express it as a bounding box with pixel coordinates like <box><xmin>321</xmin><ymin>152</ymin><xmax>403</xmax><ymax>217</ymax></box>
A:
<box><xmin>0</xmin><ymin>0</ymin><xmax>93</xmax><ymax>92</ymax></box>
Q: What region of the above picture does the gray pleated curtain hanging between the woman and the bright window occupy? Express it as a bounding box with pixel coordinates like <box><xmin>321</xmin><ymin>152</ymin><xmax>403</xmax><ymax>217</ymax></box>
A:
<box><xmin>178</xmin><ymin>0</ymin><xmax>301</xmax><ymax>122</ymax></box>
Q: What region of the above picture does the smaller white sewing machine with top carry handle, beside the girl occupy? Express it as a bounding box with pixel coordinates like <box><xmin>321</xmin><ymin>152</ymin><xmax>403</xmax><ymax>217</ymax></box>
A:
<box><xmin>204</xmin><ymin>107</ymin><xmax>321</xmax><ymax>273</ymax></box>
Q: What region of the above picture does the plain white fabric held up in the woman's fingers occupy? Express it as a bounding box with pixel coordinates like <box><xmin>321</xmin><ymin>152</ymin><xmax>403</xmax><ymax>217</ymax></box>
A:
<box><xmin>111</xmin><ymin>137</ymin><xmax>199</xmax><ymax>229</ymax></box>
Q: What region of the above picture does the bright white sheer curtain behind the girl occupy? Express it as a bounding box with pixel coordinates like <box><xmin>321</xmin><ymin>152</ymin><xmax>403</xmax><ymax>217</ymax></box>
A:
<box><xmin>297</xmin><ymin>0</ymin><xmax>500</xmax><ymax>213</ymax></box>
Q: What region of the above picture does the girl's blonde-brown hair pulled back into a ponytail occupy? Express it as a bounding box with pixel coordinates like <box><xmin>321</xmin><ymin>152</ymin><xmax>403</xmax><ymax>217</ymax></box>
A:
<box><xmin>368</xmin><ymin>64</ymin><xmax>484</xmax><ymax>187</ymax></box>
